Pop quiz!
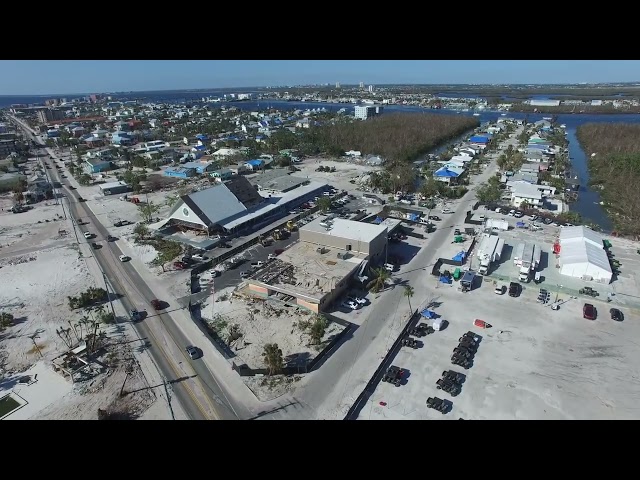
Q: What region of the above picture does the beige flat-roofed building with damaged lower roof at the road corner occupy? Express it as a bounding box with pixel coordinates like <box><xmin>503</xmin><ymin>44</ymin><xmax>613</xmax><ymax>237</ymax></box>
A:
<box><xmin>248</xmin><ymin>218</ymin><xmax>387</xmax><ymax>313</ymax></box>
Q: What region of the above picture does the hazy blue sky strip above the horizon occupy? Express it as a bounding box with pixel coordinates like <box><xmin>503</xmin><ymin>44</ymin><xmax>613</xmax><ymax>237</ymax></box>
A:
<box><xmin>0</xmin><ymin>60</ymin><xmax>640</xmax><ymax>95</ymax></box>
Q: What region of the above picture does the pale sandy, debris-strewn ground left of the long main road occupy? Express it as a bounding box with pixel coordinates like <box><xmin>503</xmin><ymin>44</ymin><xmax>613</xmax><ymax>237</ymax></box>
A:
<box><xmin>0</xmin><ymin>171</ymin><xmax>172</xmax><ymax>419</ymax></box>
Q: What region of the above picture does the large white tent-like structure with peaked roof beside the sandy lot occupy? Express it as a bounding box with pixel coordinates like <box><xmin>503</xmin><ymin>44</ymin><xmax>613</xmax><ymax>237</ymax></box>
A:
<box><xmin>560</xmin><ymin>226</ymin><xmax>613</xmax><ymax>284</ymax></box>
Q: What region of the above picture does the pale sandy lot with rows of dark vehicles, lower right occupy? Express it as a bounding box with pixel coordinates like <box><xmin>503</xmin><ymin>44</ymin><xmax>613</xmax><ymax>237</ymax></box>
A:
<box><xmin>359</xmin><ymin>276</ymin><xmax>640</xmax><ymax>420</ymax></box>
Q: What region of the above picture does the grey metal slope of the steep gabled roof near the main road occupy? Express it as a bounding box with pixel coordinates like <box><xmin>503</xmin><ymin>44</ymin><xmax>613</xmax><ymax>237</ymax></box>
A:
<box><xmin>182</xmin><ymin>184</ymin><xmax>247</xmax><ymax>226</ymax></box>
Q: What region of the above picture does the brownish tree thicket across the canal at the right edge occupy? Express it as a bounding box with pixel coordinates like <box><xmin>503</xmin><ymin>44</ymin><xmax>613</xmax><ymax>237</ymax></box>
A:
<box><xmin>576</xmin><ymin>123</ymin><xmax>640</xmax><ymax>239</ymax></box>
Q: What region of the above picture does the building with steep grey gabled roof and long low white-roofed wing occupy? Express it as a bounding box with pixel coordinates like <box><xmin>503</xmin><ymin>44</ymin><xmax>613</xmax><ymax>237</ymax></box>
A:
<box><xmin>164</xmin><ymin>177</ymin><xmax>328</xmax><ymax>235</ymax></box>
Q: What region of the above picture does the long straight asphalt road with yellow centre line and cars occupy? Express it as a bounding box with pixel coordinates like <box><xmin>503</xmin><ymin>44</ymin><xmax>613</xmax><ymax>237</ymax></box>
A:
<box><xmin>13</xmin><ymin>119</ymin><xmax>239</xmax><ymax>420</ymax></box>
